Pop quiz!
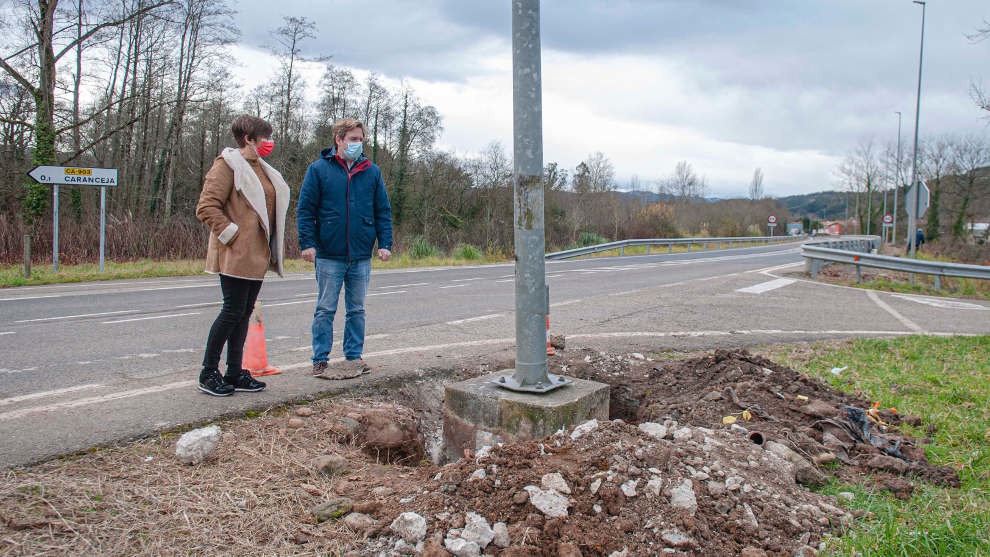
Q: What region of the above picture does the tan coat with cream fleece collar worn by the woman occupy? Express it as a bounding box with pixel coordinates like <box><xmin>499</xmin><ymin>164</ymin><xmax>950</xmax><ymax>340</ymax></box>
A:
<box><xmin>196</xmin><ymin>148</ymin><xmax>289</xmax><ymax>280</ymax></box>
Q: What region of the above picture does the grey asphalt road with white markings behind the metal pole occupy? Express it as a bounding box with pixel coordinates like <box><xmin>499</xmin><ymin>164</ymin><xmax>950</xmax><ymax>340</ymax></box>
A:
<box><xmin>0</xmin><ymin>244</ymin><xmax>990</xmax><ymax>466</ymax></box>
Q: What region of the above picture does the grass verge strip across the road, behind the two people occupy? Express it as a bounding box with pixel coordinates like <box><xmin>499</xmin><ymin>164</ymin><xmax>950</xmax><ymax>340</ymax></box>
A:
<box><xmin>0</xmin><ymin>254</ymin><xmax>509</xmax><ymax>288</ymax></box>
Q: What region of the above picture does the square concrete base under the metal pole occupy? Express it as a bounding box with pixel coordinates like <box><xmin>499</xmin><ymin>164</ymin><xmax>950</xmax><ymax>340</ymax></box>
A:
<box><xmin>443</xmin><ymin>369</ymin><xmax>609</xmax><ymax>460</ymax></box>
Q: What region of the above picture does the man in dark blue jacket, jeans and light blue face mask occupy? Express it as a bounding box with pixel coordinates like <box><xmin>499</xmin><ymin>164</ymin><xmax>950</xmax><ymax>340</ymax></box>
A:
<box><xmin>297</xmin><ymin>118</ymin><xmax>392</xmax><ymax>378</ymax></box>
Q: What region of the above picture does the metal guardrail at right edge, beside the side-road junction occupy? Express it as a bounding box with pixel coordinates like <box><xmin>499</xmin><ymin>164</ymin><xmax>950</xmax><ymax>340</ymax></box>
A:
<box><xmin>801</xmin><ymin>236</ymin><xmax>990</xmax><ymax>290</ymax></box>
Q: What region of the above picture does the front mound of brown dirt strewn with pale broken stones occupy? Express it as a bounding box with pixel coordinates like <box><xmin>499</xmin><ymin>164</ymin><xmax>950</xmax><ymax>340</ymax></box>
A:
<box><xmin>360</xmin><ymin>421</ymin><xmax>851</xmax><ymax>556</ymax></box>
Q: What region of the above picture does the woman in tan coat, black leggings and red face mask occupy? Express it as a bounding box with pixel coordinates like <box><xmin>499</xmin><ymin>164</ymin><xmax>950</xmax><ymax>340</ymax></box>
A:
<box><xmin>196</xmin><ymin>115</ymin><xmax>289</xmax><ymax>396</ymax></box>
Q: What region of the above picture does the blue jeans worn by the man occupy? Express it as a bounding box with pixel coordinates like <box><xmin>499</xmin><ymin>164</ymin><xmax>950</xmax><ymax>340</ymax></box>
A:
<box><xmin>313</xmin><ymin>259</ymin><xmax>371</xmax><ymax>363</ymax></box>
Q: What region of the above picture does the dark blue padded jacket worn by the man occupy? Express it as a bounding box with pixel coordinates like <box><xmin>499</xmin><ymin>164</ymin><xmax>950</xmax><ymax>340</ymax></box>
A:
<box><xmin>296</xmin><ymin>147</ymin><xmax>392</xmax><ymax>261</ymax></box>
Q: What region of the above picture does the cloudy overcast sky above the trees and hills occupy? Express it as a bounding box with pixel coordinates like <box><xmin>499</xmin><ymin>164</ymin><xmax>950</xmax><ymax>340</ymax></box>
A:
<box><xmin>227</xmin><ymin>0</ymin><xmax>990</xmax><ymax>197</ymax></box>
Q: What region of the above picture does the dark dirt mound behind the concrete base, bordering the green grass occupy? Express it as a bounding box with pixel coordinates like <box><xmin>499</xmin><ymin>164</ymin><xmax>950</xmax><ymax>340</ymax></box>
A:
<box><xmin>567</xmin><ymin>350</ymin><xmax>959</xmax><ymax>487</ymax></box>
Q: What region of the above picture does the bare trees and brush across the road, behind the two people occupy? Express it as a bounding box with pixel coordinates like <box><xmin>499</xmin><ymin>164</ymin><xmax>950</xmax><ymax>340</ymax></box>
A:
<box><xmin>0</xmin><ymin>0</ymin><xmax>789</xmax><ymax>263</ymax></box>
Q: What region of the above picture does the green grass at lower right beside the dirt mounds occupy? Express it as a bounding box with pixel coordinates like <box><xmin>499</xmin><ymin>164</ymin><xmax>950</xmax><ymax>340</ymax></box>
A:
<box><xmin>767</xmin><ymin>336</ymin><xmax>990</xmax><ymax>556</ymax></box>
